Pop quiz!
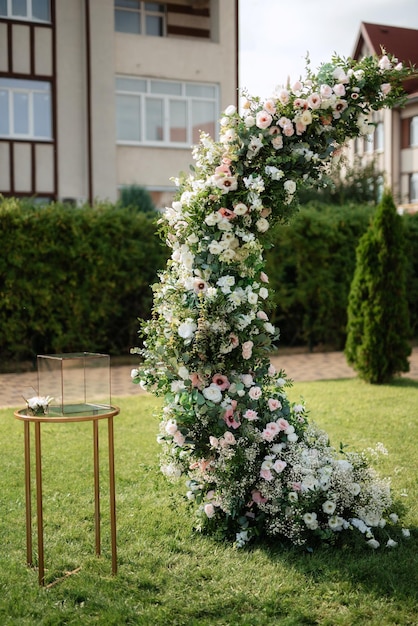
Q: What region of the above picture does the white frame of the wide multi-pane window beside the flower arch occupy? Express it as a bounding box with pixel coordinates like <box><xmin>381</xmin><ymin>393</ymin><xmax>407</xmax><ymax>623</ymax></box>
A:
<box><xmin>116</xmin><ymin>76</ymin><xmax>219</xmax><ymax>149</ymax></box>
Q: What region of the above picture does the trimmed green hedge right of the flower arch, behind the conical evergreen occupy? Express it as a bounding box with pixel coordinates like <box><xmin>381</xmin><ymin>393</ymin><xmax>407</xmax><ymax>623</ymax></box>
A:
<box><xmin>267</xmin><ymin>205</ymin><xmax>418</xmax><ymax>350</ymax></box>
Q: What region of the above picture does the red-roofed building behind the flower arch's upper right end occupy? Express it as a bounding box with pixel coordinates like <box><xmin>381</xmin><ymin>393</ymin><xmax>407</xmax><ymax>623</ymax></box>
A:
<box><xmin>349</xmin><ymin>22</ymin><xmax>418</xmax><ymax>211</ymax></box>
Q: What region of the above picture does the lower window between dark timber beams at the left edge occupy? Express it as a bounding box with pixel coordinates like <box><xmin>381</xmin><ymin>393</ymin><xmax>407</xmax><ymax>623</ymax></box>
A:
<box><xmin>0</xmin><ymin>78</ymin><xmax>52</xmax><ymax>139</ymax></box>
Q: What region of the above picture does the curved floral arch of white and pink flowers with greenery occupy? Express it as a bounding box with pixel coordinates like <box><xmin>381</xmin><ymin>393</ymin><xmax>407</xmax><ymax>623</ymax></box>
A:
<box><xmin>132</xmin><ymin>54</ymin><xmax>412</xmax><ymax>547</ymax></box>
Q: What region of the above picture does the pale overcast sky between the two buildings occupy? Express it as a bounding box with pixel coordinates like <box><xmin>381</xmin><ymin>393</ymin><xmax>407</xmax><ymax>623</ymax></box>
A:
<box><xmin>239</xmin><ymin>0</ymin><xmax>418</xmax><ymax>97</ymax></box>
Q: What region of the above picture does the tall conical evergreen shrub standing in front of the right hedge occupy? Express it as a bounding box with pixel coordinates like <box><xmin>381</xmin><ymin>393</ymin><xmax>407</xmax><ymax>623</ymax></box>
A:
<box><xmin>345</xmin><ymin>192</ymin><xmax>411</xmax><ymax>384</ymax></box>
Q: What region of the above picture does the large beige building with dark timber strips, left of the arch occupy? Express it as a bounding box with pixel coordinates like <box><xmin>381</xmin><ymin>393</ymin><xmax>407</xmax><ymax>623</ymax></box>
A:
<box><xmin>0</xmin><ymin>0</ymin><xmax>238</xmax><ymax>206</ymax></box>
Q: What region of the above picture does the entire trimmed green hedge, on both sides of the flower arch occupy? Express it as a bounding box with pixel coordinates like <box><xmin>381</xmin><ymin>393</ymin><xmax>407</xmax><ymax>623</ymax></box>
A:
<box><xmin>0</xmin><ymin>198</ymin><xmax>418</xmax><ymax>367</ymax></box>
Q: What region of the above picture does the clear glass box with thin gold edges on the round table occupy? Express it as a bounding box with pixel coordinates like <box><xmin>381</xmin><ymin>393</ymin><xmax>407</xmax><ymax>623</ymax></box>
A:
<box><xmin>37</xmin><ymin>352</ymin><xmax>111</xmax><ymax>416</ymax></box>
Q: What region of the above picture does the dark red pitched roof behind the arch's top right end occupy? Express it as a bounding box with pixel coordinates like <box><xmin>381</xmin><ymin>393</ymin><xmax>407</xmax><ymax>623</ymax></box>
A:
<box><xmin>352</xmin><ymin>22</ymin><xmax>418</xmax><ymax>94</ymax></box>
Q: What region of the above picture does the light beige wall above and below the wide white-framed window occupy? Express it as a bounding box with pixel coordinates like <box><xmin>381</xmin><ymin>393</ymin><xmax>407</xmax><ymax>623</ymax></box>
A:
<box><xmin>115</xmin><ymin>0</ymin><xmax>237</xmax><ymax>197</ymax></box>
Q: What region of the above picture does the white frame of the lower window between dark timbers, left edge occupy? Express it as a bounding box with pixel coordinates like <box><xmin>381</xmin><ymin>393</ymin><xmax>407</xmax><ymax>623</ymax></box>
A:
<box><xmin>0</xmin><ymin>78</ymin><xmax>52</xmax><ymax>141</ymax></box>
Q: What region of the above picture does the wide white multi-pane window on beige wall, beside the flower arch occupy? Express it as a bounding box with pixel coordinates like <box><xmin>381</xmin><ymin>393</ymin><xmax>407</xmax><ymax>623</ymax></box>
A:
<box><xmin>116</xmin><ymin>77</ymin><xmax>219</xmax><ymax>148</ymax></box>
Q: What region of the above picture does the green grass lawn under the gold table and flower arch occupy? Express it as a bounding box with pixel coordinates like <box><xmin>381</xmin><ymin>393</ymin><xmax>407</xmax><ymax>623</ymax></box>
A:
<box><xmin>0</xmin><ymin>379</ymin><xmax>418</xmax><ymax>626</ymax></box>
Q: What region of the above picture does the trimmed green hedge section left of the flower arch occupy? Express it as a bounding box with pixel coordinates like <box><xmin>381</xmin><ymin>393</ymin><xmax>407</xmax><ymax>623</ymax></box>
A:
<box><xmin>0</xmin><ymin>198</ymin><xmax>167</xmax><ymax>361</ymax></box>
